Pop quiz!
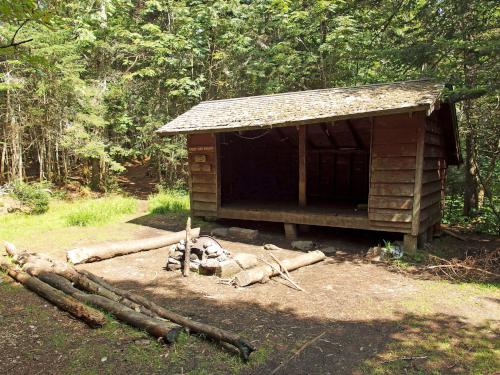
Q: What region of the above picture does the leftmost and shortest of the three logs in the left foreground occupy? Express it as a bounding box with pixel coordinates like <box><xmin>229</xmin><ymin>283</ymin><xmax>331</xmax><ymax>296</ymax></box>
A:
<box><xmin>0</xmin><ymin>262</ymin><xmax>106</xmax><ymax>328</ymax></box>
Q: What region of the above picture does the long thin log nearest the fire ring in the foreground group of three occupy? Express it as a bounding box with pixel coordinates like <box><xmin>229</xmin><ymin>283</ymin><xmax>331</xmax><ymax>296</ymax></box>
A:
<box><xmin>81</xmin><ymin>271</ymin><xmax>255</xmax><ymax>360</ymax></box>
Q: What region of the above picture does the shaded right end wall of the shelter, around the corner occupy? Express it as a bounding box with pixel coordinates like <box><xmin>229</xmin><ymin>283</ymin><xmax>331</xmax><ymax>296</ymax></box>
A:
<box><xmin>419</xmin><ymin>116</ymin><xmax>447</xmax><ymax>233</ymax></box>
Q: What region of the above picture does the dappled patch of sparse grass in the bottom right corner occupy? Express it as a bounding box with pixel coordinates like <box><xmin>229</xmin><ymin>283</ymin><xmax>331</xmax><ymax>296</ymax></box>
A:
<box><xmin>361</xmin><ymin>316</ymin><xmax>500</xmax><ymax>374</ymax></box>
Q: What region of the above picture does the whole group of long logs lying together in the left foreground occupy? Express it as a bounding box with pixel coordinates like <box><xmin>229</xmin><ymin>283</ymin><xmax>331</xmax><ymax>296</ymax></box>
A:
<box><xmin>0</xmin><ymin>244</ymin><xmax>255</xmax><ymax>360</ymax></box>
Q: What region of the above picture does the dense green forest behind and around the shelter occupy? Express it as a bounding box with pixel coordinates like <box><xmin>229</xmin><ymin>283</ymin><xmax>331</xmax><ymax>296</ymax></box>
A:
<box><xmin>0</xmin><ymin>0</ymin><xmax>500</xmax><ymax>233</ymax></box>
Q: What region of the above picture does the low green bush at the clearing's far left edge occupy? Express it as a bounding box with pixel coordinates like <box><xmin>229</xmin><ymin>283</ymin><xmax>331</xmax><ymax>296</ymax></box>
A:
<box><xmin>11</xmin><ymin>182</ymin><xmax>50</xmax><ymax>215</ymax></box>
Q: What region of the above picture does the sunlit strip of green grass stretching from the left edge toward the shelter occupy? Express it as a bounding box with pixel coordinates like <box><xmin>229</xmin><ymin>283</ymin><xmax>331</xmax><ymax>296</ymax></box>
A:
<box><xmin>0</xmin><ymin>196</ymin><xmax>137</xmax><ymax>241</ymax></box>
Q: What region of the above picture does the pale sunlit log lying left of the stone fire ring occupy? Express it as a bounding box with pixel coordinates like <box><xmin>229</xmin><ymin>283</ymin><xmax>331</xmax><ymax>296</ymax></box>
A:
<box><xmin>66</xmin><ymin>228</ymin><xmax>200</xmax><ymax>264</ymax></box>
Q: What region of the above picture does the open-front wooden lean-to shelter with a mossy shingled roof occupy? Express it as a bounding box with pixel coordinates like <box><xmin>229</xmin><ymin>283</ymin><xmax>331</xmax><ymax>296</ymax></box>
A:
<box><xmin>158</xmin><ymin>80</ymin><xmax>461</xmax><ymax>251</ymax></box>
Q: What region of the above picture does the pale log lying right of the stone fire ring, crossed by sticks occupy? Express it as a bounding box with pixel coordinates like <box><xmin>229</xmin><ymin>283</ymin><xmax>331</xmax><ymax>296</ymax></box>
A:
<box><xmin>234</xmin><ymin>250</ymin><xmax>326</xmax><ymax>287</ymax></box>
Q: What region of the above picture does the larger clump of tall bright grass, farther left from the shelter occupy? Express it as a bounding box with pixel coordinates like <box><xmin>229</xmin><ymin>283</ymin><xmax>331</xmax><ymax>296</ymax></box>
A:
<box><xmin>65</xmin><ymin>196</ymin><xmax>137</xmax><ymax>227</ymax></box>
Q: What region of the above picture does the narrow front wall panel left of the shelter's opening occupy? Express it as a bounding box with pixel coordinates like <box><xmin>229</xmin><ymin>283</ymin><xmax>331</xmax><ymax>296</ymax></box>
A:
<box><xmin>187</xmin><ymin>134</ymin><xmax>219</xmax><ymax>217</ymax></box>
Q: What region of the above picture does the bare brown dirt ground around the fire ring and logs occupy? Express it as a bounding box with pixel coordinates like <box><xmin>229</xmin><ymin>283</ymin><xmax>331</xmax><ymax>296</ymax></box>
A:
<box><xmin>0</xmin><ymin>215</ymin><xmax>500</xmax><ymax>374</ymax></box>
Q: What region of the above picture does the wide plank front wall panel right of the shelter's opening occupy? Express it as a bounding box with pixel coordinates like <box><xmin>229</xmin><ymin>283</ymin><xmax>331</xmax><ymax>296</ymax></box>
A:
<box><xmin>368</xmin><ymin>112</ymin><xmax>425</xmax><ymax>233</ymax></box>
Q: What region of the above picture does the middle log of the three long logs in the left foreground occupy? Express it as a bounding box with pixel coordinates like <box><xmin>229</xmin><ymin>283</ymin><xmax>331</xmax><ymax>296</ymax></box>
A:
<box><xmin>39</xmin><ymin>273</ymin><xmax>182</xmax><ymax>343</ymax></box>
